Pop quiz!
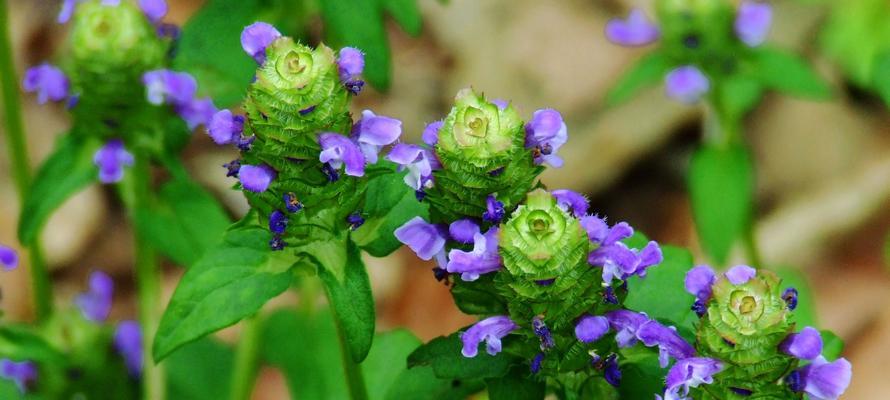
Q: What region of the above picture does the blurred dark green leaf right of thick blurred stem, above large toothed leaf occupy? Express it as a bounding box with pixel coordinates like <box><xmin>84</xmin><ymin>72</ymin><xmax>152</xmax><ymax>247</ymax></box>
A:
<box><xmin>135</xmin><ymin>178</ymin><xmax>232</xmax><ymax>267</ymax></box>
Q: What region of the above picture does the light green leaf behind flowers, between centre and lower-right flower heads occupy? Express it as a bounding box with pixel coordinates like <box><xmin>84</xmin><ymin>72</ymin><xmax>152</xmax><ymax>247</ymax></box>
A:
<box><xmin>624</xmin><ymin>246</ymin><xmax>698</xmax><ymax>336</ymax></box>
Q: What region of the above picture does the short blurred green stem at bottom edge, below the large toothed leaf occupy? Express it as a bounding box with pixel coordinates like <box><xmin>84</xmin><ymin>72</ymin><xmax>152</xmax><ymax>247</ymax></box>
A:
<box><xmin>230</xmin><ymin>315</ymin><xmax>262</xmax><ymax>400</ymax></box>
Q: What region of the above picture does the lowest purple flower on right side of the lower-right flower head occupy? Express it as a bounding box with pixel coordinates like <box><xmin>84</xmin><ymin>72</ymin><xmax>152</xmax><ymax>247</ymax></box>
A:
<box><xmin>792</xmin><ymin>356</ymin><xmax>853</xmax><ymax>400</ymax></box>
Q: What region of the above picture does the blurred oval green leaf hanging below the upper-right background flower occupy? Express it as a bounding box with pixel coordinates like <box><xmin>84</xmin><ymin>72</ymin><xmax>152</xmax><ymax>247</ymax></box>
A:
<box><xmin>689</xmin><ymin>145</ymin><xmax>754</xmax><ymax>265</ymax></box>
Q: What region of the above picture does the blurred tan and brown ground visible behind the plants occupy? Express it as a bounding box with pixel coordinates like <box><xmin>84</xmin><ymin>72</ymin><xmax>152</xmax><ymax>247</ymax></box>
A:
<box><xmin>0</xmin><ymin>0</ymin><xmax>890</xmax><ymax>399</ymax></box>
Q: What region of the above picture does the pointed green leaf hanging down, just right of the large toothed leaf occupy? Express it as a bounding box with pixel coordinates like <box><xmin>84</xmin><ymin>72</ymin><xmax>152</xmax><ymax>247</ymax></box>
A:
<box><xmin>316</xmin><ymin>243</ymin><xmax>375</xmax><ymax>363</ymax></box>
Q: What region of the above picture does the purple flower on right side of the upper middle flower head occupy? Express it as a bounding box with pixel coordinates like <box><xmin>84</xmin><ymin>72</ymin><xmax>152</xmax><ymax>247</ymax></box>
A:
<box><xmin>525</xmin><ymin>108</ymin><xmax>569</xmax><ymax>168</ymax></box>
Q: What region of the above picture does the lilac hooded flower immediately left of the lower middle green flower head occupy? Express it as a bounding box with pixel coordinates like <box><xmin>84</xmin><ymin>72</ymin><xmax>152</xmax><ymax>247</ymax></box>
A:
<box><xmin>445</xmin><ymin>228</ymin><xmax>501</xmax><ymax>281</ymax></box>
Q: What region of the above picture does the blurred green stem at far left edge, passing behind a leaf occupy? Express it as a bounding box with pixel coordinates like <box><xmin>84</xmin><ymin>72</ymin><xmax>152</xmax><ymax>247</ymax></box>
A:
<box><xmin>0</xmin><ymin>0</ymin><xmax>53</xmax><ymax>321</ymax></box>
